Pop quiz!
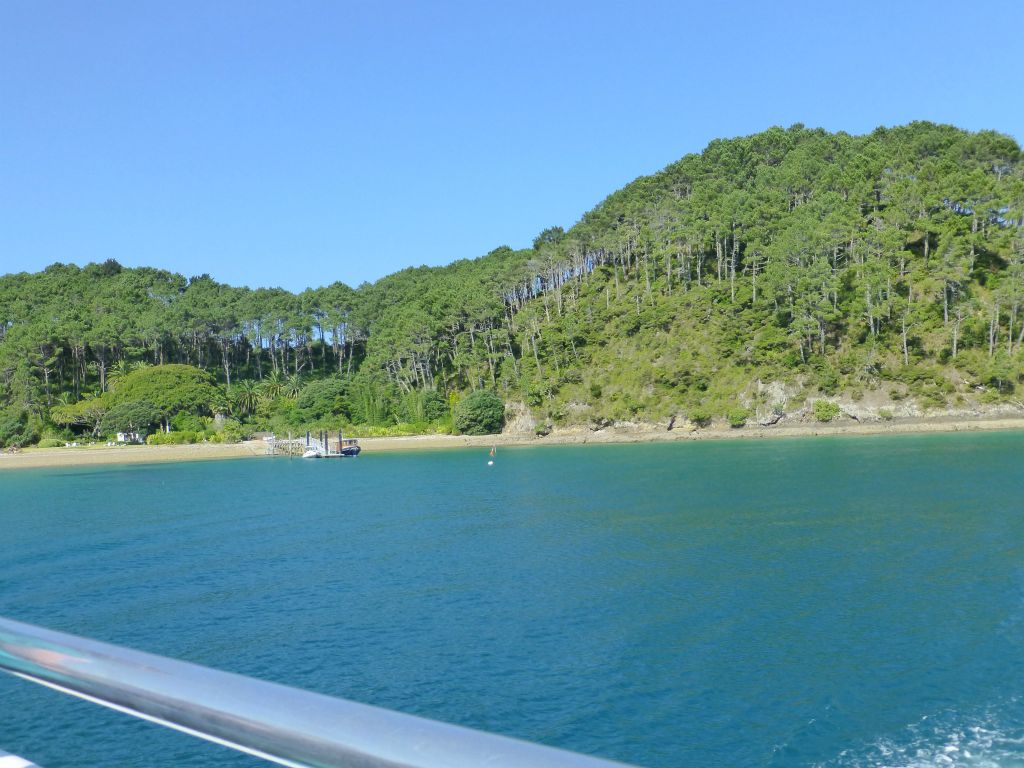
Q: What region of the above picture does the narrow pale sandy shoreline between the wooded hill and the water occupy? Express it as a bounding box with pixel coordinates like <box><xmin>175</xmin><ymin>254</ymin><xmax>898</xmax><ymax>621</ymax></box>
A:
<box><xmin>6</xmin><ymin>415</ymin><xmax>1024</xmax><ymax>472</ymax></box>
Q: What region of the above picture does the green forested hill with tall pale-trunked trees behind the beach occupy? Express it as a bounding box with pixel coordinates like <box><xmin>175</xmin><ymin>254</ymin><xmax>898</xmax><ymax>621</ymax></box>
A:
<box><xmin>0</xmin><ymin>123</ymin><xmax>1024</xmax><ymax>442</ymax></box>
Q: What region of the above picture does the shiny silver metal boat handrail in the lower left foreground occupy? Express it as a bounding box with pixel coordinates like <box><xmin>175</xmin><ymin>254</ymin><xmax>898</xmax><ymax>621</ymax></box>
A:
<box><xmin>0</xmin><ymin>617</ymin><xmax>623</xmax><ymax>768</ymax></box>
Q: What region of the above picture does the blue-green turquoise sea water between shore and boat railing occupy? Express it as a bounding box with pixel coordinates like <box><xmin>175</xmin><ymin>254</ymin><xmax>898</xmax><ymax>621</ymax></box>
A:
<box><xmin>0</xmin><ymin>434</ymin><xmax>1024</xmax><ymax>768</ymax></box>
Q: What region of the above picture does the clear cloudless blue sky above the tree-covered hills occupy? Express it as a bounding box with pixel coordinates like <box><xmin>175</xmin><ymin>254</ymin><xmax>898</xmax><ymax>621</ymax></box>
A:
<box><xmin>0</xmin><ymin>0</ymin><xmax>1024</xmax><ymax>291</ymax></box>
